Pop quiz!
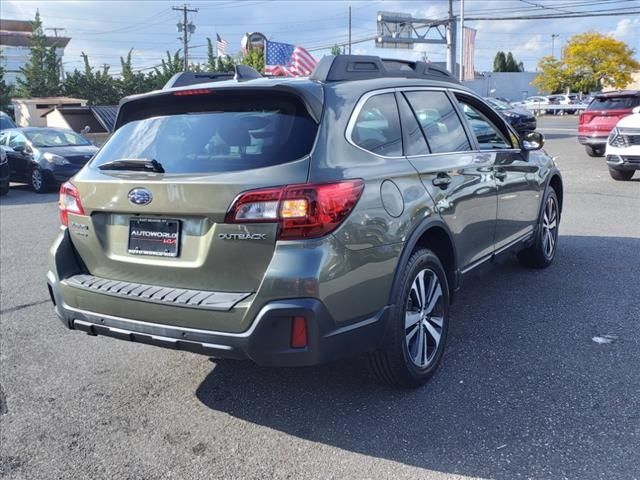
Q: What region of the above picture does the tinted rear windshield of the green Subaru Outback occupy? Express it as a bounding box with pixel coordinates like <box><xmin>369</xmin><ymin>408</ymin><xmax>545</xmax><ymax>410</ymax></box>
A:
<box><xmin>91</xmin><ymin>92</ymin><xmax>318</xmax><ymax>174</ymax></box>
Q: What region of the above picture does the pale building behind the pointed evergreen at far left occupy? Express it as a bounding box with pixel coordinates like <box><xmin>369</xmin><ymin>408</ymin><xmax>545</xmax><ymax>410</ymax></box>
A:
<box><xmin>0</xmin><ymin>19</ymin><xmax>71</xmax><ymax>85</ymax></box>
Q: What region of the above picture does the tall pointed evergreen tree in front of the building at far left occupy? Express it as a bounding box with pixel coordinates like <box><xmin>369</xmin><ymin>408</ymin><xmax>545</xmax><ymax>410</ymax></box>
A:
<box><xmin>17</xmin><ymin>12</ymin><xmax>60</xmax><ymax>98</ymax></box>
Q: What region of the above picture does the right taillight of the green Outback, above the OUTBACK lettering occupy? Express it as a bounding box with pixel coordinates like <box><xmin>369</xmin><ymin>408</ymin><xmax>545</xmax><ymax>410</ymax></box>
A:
<box><xmin>225</xmin><ymin>180</ymin><xmax>364</xmax><ymax>240</ymax></box>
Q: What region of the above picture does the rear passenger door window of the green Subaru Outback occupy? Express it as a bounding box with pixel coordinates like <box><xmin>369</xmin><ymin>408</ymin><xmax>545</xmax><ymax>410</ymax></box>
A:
<box><xmin>405</xmin><ymin>91</ymin><xmax>471</xmax><ymax>153</ymax></box>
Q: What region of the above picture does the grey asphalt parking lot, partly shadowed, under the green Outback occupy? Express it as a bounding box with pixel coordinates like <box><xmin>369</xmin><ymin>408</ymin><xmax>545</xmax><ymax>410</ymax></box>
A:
<box><xmin>0</xmin><ymin>116</ymin><xmax>640</xmax><ymax>480</ymax></box>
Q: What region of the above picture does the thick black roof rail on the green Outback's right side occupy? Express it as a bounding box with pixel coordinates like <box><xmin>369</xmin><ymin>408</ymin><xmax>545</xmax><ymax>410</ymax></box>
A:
<box><xmin>309</xmin><ymin>55</ymin><xmax>460</xmax><ymax>84</ymax></box>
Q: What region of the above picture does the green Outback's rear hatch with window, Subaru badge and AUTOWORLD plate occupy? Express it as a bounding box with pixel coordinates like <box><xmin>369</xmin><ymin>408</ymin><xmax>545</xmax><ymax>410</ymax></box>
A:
<box><xmin>69</xmin><ymin>88</ymin><xmax>318</xmax><ymax>293</ymax></box>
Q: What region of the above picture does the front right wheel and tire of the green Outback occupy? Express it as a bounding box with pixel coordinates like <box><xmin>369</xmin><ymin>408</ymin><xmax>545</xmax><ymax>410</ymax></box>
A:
<box><xmin>518</xmin><ymin>186</ymin><xmax>560</xmax><ymax>268</ymax></box>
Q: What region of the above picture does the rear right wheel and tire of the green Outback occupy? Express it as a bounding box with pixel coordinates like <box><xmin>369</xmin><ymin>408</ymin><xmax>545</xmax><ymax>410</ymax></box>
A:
<box><xmin>369</xmin><ymin>249</ymin><xmax>449</xmax><ymax>388</ymax></box>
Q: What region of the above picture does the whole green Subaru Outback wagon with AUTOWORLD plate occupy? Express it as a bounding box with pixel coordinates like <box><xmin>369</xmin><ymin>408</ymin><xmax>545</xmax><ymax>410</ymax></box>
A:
<box><xmin>47</xmin><ymin>56</ymin><xmax>563</xmax><ymax>386</ymax></box>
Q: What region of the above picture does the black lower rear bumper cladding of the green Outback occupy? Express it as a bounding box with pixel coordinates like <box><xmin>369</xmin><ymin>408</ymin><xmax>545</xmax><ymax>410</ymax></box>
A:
<box><xmin>47</xmin><ymin>272</ymin><xmax>390</xmax><ymax>366</ymax></box>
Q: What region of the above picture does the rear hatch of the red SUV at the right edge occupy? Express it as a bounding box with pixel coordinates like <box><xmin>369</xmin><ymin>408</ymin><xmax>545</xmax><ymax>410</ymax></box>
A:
<box><xmin>578</xmin><ymin>93</ymin><xmax>640</xmax><ymax>137</ymax></box>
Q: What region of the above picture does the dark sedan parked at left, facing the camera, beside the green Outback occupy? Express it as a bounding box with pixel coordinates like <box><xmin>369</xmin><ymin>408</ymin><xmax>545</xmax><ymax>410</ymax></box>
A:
<box><xmin>0</xmin><ymin>127</ymin><xmax>98</xmax><ymax>193</ymax></box>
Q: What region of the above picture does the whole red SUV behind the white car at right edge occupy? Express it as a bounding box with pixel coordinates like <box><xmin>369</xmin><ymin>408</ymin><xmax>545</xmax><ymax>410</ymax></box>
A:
<box><xmin>578</xmin><ymin>90</ymin><xmax>640</xmax><ymax>157</ymax></box>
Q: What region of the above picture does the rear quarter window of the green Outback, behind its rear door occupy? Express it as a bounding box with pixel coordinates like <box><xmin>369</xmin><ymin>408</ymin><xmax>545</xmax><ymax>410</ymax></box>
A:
<box><xmin>351</xmin><ymin>93</ymin><xmax>402</xmax><ymax>157</ymax></box>
